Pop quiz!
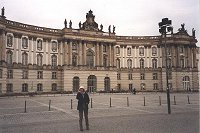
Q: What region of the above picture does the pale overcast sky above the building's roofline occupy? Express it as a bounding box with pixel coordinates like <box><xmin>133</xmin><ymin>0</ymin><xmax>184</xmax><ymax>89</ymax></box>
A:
<box><xmin>0</xmin><ymin>0</ymin><xmax>200</xmax><ymax>46</ymax></box>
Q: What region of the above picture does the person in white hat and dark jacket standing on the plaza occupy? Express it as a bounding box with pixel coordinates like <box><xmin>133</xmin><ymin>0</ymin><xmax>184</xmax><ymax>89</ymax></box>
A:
<box><xmin>76</xmin><ymin>86</ymin><xmax>90</xmax><ymax>131</ymax></box>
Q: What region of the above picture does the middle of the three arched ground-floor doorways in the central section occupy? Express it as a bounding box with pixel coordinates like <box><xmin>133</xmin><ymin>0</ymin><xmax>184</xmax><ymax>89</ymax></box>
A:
<box><xmin>87</xmin><ymin>75</ymin><xmax>97</xmax><ymax>92</ymax></box>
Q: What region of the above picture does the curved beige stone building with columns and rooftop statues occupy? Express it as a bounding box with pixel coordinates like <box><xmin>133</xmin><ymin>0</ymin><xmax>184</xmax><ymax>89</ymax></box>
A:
<box><xmin>0</xmin><ymin>10</ymin><xmax>199</xmax><ymax>93</ymax></box>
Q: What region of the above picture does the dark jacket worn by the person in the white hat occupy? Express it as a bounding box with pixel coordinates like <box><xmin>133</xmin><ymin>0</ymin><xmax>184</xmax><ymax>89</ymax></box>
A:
<box><xmin>76</xmin><ymin>92</ymin><xmax>90</xmax><ymax>111</ymax></box>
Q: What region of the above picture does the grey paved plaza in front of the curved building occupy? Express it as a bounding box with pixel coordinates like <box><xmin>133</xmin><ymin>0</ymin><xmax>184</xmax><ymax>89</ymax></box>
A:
<box><xmin>0</xmin><ymin>93</ymin><xmax>199</xmax><ymax>133</ymax></box>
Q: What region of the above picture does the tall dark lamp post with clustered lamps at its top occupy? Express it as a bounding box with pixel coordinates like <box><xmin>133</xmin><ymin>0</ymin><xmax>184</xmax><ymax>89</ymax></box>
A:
<box><xmin>158</xmin><ymin>18</ymin><xmax>173</xmax><ymax>114</ymax></box>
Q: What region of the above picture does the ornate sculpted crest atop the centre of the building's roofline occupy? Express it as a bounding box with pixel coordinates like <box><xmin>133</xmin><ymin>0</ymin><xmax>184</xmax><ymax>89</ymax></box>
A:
<box><xmin>79</xmin><ymin>10</ymin><xmax>99</xmax><ymax>31</ymax></box>
